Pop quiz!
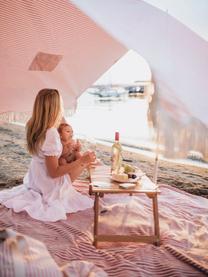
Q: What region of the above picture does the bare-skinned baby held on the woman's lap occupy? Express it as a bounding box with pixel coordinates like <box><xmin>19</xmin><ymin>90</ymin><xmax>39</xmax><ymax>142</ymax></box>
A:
<box><xmin>58</xmin><ymin>123</ymin><xmax>82</xmax><ymax>165</ymax></box>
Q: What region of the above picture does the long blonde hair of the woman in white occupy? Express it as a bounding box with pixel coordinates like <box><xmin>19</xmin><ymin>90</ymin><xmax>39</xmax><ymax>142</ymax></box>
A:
<box><xmin>26</xmin><ymin>88</ymin><xmax>62</xmax><ymax>154</ymax></box>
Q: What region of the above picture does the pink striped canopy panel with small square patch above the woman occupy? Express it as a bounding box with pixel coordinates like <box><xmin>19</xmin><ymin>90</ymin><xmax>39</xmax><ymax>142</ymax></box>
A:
<box><xmin>0</xmin><ymin>0</ymin><xmax>127</xmax><ymax>113</ymax></box>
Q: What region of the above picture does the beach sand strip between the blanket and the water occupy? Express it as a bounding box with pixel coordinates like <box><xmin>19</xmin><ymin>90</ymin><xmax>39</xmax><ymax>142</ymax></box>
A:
<box><xmin>0</xmin><ymin>123</ymin><xmax>208</xmax><ymax>198</ymax></box>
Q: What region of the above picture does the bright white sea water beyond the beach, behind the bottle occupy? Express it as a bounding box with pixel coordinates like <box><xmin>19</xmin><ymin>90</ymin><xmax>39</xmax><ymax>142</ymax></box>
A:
<box><xmin>67</xmin><ymin>92</ymin><xmax>208</xmax><ymax>168</ymax></box>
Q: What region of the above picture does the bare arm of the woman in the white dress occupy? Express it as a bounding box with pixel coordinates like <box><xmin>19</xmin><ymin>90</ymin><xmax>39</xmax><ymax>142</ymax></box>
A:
<box><xmin>45</xmin><ymin>152</ymin><xmax>96</xmax><ymax>182</ymax></box>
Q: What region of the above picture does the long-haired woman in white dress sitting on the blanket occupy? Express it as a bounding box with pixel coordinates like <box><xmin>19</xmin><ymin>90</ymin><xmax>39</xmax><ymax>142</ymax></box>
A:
<box><xmin>0</xmin><ymin>89</ymin><xmax>96</xmax><ymax>221</ymax></box>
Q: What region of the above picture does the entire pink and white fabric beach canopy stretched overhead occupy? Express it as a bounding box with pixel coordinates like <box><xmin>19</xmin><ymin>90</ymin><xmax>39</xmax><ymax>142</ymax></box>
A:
<box><xmin>0</xmin><ymin>0</ymin><xmax>208</xmax><ymax>157</ymax></box>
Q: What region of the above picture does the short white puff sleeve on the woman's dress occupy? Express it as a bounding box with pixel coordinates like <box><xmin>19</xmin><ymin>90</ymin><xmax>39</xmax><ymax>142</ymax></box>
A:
<box><xmin>41</xmin><ymin>128</ymin><xmax>62</xmax><ymax>156</ymax></box>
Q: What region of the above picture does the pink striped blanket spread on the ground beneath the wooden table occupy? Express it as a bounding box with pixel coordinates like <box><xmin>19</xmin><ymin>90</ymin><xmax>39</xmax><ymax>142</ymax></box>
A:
<box><xmin>0</xmin><ymin>183</ymin><xmax>208</xmax><ymax>277</ymax></box>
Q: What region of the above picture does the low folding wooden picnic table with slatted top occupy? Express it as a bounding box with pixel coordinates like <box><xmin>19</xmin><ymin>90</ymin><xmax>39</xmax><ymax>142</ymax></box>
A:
<box><xmin>89</xmin><ymin>165</ymin><xmax>160</xmax><ymax>247</ymax></box>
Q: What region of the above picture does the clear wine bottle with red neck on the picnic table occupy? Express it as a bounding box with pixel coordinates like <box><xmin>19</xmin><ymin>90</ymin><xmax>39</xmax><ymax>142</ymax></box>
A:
<box><xmin>111</xmin><ymin>132</ymin><xmax>122</xmax><ymax>174</ymax></box>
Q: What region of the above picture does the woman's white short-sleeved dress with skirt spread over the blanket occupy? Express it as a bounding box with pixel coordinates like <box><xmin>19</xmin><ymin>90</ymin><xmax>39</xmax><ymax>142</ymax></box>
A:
<box><xmin>0</xmin><ymin>128</ymin><xmax>93</xmax><ymax>221</ymax></box>
